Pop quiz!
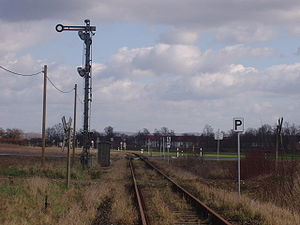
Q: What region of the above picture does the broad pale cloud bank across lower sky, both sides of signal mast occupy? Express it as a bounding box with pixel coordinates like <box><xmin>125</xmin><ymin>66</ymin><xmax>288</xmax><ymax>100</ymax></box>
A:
<box><xmin>0</xmin><ymin>39</ymin><xmax>300</xmax><ymax>132</ymax></box>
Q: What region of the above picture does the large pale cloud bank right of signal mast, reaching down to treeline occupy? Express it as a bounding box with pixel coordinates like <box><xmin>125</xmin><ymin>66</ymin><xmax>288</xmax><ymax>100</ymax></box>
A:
<box><xmin>86</xmin><ymin>40</ymin><xmax>300</xmax><ymax>131</ymax></box>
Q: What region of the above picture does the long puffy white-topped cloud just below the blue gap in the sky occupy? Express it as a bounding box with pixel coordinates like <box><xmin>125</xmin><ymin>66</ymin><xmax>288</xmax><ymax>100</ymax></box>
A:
<box><xmin>100</xmin><ymin>44</ymin><xmax>275</xmax><ymax>79</ymax></box>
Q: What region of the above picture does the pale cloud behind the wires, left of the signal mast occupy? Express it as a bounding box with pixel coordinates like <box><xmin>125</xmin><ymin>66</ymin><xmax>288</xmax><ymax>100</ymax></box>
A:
<box><xmin>0</xmin><ymin>54</ymin><xmax>82</xmax><ymax>132</ymax></box>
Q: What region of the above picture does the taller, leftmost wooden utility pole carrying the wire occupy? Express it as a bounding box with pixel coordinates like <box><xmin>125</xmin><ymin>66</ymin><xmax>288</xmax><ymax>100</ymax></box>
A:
<box><xmin>42</xmin><ymin>65</ymin><xmax>47</xmax><ymax>166</ymax></box>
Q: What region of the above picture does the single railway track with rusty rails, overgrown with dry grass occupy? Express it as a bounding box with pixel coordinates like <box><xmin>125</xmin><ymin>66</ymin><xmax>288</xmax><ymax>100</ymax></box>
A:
<box><xmin>129</xmin><ymin>155</ymin><xmax>232</xmax><ymax>225</ymax></box>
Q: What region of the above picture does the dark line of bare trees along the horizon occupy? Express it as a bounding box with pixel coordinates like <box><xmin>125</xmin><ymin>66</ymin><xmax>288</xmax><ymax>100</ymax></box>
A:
<box><xmin>0</xmin><ymin>121</ymin><xmax>300</xmax><ymax>151</ymax></box>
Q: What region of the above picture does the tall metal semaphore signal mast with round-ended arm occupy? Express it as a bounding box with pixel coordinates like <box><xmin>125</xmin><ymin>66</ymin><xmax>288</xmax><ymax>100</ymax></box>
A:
<box><xmin>55</xmin><ymin>19</ymin><xmax>96</xmax><ymax>168</ymax></box>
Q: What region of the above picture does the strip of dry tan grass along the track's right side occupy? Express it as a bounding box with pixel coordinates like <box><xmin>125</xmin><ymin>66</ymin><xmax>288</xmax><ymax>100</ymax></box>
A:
<box><xmin>155</xmin><ymin>160</ymin><xmax>300</xmax><ymax>225</ymax></box>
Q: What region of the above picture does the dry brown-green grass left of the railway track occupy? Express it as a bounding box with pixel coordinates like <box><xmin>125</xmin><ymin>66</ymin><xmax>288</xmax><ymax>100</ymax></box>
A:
<box><xmin>0</xmin><ymin>155</ymin><xmax>137</xmax><ymax>225</ymax></box>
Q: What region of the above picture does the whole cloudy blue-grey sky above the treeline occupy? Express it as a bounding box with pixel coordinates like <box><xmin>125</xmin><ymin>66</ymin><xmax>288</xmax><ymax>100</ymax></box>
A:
<box><xmin>0</xmin><ymin>0</ymin><xmax>300</xmax><ymax>133</ymax></box>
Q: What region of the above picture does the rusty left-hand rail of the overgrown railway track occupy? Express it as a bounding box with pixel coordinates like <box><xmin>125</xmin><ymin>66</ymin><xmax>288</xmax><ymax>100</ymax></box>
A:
<box><xmin>129</xmin><ymin>158</ymin><xmax>150</xmax><ymax>225</ymax></box>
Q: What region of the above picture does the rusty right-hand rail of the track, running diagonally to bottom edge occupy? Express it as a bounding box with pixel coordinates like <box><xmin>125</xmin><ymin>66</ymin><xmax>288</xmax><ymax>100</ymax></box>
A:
<box><xmin>135</xmin><ymin>154</ymin><xmax>232</xmax><ymax>225</ymax></box>
